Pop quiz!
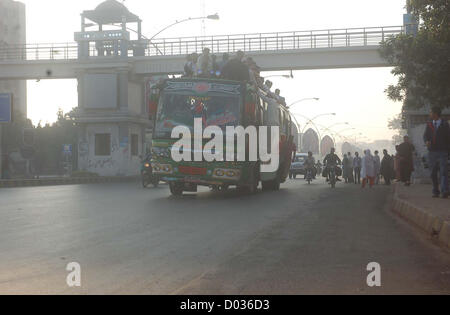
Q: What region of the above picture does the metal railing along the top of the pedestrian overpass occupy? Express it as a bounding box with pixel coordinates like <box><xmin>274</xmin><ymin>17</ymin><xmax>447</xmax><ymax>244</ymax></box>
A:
<box><xmin>0</xmin><ymin>26</ymin><xmax>404</xmax><ymax>61</ymax></box>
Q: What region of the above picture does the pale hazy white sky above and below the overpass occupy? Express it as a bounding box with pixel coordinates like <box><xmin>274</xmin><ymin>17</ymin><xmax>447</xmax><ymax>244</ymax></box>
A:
<box><xmin>22</xmin><ymin>0</ymin><xmax>405</xmax><ymax>140</ymax></box>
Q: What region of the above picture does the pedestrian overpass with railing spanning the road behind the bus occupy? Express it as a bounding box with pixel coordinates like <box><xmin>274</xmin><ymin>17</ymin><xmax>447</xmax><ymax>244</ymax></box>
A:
<box><xmin>0</xmin><ymin>26</ymin><xmax>404</xmax><ymax>80</ymax></box>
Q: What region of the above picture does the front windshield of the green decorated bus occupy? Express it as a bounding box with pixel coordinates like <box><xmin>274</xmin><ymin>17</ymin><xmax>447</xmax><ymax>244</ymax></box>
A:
<box><xmin>155</xmin><ymin>91</ymin><xmax>241</xmax><ymax>139</ymax></box>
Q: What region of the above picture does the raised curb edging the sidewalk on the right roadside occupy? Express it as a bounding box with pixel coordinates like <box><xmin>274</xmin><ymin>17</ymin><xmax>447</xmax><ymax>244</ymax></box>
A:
<box><xmin>392</xmin><ymin>189</ymin><xmax>450</xmax><ymax>249</ymax></box>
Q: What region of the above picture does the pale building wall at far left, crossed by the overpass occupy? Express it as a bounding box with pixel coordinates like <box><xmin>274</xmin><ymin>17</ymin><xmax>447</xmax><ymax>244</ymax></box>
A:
<box><xmin>0</xmin><ymin>0</ymin><xmax>27</xmax><ymax>115</ymax></box>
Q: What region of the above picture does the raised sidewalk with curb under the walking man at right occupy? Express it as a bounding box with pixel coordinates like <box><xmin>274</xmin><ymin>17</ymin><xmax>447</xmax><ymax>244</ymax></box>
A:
<box><xmin>392</xmin><ymin>183</ymin><xmax>450</xmax><ymax>248</ymax></box>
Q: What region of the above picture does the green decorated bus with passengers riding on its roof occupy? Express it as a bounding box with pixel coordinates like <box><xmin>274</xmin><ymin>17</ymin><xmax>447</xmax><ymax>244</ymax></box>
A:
<box><xmin>152</xmin><ymin>78</ymin><xmax>294</xmax><ymax>196</ymax></box>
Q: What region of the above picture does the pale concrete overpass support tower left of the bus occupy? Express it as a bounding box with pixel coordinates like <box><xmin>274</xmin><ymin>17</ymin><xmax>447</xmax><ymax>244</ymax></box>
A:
<box><xmin>75</xmin><ymin>65</ymin><xmax>150</xmax><ymax>176</ymax></box>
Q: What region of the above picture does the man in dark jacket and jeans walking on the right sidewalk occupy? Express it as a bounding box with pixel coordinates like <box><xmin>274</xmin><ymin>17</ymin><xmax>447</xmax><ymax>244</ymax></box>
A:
<box><xmin>423</xmin><ymin>107</ymin><xmax>450</xmax><ymax>199</ymax></box>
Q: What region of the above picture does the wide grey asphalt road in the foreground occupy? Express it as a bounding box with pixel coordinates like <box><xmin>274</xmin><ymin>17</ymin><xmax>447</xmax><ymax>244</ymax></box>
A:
<box><xmin>0</xmin><ymin>180</ymin><xmax>450</xmax><ymax>294</ymax></box>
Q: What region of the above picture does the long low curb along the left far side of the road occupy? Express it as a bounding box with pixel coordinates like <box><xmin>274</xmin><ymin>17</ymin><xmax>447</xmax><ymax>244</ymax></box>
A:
<box><xmin>0</xmin><ymin>176</ymin><xmax>140</xmax><ymax>188</ymax></box>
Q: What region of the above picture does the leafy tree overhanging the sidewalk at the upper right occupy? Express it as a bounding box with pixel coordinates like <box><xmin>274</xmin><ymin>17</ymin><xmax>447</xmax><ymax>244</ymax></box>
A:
<box><xmin>380</xmin><ymin>0</ymin><xmax>450</xmax><ymax>108</ymax></box>
